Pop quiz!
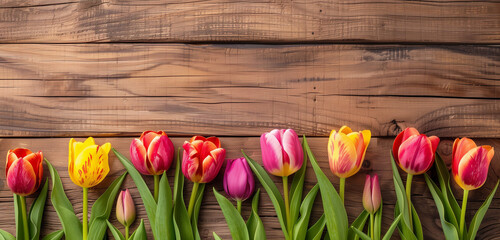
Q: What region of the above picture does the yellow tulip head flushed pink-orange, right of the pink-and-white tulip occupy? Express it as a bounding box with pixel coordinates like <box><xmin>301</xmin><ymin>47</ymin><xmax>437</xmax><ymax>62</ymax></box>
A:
<box><xmin>328</xmin><ymin>126</ymin><xmax>372</xmax><ymax>178</ymax></box>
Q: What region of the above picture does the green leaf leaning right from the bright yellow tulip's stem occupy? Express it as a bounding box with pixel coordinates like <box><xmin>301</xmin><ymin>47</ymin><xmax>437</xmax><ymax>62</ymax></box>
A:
<box><xmin>88</xmin><ymin>172</ymin><xmax>127</xmax><ymax>239</ymax></box>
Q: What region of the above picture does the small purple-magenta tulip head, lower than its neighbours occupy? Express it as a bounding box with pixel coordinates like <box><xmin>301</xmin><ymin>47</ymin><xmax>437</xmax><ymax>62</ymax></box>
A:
<box><xmin>224</xmin><ymin>158</ymin><xmax>255</xmax><ymax>201</ymax></box>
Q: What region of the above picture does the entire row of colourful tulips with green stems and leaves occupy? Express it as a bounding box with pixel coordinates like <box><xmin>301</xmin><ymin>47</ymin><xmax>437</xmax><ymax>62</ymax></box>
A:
<box><xmin>0</xmin><ymin>126</ymin><xmax>498</xmax><ymax>240</ymax></box>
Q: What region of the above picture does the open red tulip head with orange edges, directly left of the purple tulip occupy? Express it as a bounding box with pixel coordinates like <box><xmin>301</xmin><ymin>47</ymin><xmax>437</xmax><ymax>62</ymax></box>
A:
<box><xmin>182</xmin><ymin>136</ymin><xmax>226</xmax><ymax>183</ymax></box>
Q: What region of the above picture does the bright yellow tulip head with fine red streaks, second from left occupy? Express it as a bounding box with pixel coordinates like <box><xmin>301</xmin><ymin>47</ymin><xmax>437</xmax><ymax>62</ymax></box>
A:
<box><xmin>68</xmin><ymin>137</ymin><xmax>111</xmax><ymax>188</ymax></box>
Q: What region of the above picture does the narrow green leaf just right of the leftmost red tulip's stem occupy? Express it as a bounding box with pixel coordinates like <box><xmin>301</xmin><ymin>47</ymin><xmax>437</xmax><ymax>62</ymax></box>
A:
<box><xmin>28</xmin><ymin>180</ymin><xmax>49</xmax><ymax>240</ymax></box>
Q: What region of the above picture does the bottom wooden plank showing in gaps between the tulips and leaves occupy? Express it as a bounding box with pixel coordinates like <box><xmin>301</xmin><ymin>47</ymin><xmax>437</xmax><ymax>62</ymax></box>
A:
<box><xmin>0</xmin><ymin>137</ymin><xmax>500</xmax><ymax>239</ymax></box>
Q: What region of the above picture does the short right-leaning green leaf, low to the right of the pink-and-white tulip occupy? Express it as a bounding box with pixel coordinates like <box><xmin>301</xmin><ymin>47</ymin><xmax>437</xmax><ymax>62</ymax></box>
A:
<box><xmin>293</xmin><ymin>185</ymin><xmax>319</xmax><ymax>239</ymax></box>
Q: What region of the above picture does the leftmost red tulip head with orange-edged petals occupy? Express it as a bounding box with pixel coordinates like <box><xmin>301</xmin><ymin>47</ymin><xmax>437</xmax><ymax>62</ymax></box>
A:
<box><xmin>5</xmin><ymin>148</ymin><xmax>43</xmax><ymax>196</ymax></box>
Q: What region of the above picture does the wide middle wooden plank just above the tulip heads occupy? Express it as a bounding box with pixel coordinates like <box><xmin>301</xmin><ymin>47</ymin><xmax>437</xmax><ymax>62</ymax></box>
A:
<box><xmin>0</xmin><ymin>44</ymin><xmax>500</xmax><ymax>137</ymax></box>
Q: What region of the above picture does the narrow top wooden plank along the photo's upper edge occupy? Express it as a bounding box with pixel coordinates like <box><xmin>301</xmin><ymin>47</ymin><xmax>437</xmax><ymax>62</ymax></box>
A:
<box><xmin>0</xmin><ymin>0</ymin><xmax>500</xmax><ymax>43</ymax></box>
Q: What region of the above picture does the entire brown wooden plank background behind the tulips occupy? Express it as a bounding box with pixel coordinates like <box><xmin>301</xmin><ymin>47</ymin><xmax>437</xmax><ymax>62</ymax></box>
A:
<box><xmin>0</xmin><ymin>0</ymin><xmax>500</xmax><ymax>239</ymax></box>
